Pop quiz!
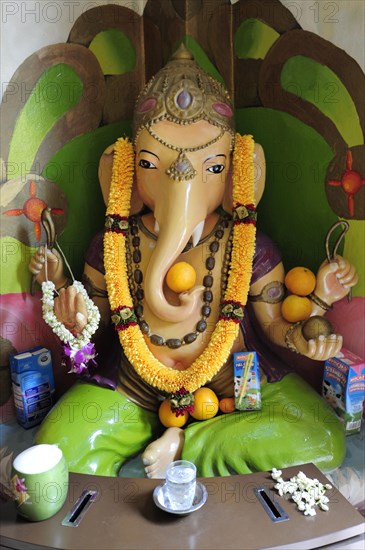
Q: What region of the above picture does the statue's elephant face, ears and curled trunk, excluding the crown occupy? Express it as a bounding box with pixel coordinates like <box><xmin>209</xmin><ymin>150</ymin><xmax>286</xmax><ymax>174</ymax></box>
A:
<box><xmin>99</xmin><ymin>121</ymin><xmax>265</xmax><ymax>323</ymax></box>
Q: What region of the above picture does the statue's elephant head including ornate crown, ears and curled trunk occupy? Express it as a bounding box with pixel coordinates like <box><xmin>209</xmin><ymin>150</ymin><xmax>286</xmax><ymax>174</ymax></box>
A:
<box><xmin>99</xmin><ymin>46</ymin><xmax>264</xmax><ymax>323</ymax></box>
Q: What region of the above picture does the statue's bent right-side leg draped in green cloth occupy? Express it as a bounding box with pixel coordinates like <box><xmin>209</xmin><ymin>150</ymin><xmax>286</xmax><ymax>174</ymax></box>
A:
<box><xmin>183</xmin><ymin>373</ymin><xmax>346</xmax><ymax>478</ymax></box>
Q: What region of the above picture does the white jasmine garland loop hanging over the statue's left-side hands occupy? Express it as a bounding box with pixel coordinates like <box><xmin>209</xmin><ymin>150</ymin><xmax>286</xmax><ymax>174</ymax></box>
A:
<box><xmin>42</xmin><ymin>281</ymin><xmax>100</xmax><ymax>370</ymax></box>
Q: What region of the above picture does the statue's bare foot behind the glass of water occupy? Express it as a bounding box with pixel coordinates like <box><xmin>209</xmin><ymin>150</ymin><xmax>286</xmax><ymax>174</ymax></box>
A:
<box><xmin>142</xmin><ymin>428</ymin><xmax>184</xmax><ymax>479</ymax></box>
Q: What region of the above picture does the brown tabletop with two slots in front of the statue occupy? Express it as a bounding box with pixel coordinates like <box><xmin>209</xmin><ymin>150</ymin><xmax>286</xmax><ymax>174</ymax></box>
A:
<box><xmin>0</xmin><ymin>464</ymin><xmax>364</xmax><ymax>550</ymax></box>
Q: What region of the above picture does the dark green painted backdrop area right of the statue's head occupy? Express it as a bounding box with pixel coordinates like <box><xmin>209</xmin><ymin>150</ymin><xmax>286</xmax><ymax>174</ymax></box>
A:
<box><xmin>236</xmin><ymin>108</ymin><xmax>337</xmax><ymax>271</ymax></box>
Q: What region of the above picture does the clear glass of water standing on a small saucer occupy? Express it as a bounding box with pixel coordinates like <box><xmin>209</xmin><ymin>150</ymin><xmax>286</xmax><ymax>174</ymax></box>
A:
<box><xmin>164</xmin><ymin>460</ymin><xmax>196</xmax><ymax>510</ymax></box>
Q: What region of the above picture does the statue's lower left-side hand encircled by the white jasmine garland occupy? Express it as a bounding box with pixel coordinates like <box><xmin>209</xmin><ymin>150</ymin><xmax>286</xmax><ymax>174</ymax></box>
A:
<box><xmin>54</xmin><ymin>286</ymin><xmax>87</xmax><ymax>336</ymax></box>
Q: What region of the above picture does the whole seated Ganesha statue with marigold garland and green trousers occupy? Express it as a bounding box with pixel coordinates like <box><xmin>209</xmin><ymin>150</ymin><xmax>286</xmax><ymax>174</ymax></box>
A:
<box><xmin>30</xmin><ymin>46</ymin><xmax>357</xmax><ymax>478</ymax></box>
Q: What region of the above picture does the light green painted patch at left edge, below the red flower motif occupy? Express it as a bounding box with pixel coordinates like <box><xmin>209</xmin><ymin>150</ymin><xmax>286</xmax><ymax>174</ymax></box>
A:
<box><xmin>0</xmin><ymin>237</ymin><xmax>35</xmax><ymax>294</ymax></box>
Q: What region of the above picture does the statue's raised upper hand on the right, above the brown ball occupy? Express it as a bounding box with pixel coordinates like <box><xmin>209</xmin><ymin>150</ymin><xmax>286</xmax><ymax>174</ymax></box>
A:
<box><xmin>314</xmin><ymin>256</ymin><xmax>359</xmax><ymax>305</ymax></box>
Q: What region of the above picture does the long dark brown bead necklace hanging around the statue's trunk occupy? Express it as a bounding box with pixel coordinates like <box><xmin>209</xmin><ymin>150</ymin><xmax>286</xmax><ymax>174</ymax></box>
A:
<box><xmin>127</xmin><ymin>216</ymin><xmax>228</xmax><ymax>349</ymax></box>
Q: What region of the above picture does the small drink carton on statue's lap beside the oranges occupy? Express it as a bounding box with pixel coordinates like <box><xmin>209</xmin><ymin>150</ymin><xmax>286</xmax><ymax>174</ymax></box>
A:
<box><xmin>233</xmin><ymin>351</ymin><xmax>261</xmax><ymax>411</ymax></box>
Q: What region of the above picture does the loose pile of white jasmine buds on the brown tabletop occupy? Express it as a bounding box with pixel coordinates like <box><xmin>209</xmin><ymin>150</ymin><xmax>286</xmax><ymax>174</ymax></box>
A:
<box><xmin>271</xmin><ymin>468</ymin><xmax>332</xmax><ymax>516</ymax></box>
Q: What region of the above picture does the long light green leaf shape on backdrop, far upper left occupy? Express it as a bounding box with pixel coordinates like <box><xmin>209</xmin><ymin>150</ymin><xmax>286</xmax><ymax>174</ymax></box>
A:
<box><xmin>8</xmin><ymin>63</ymin><xmax>83</xmax><ymax>178</ymax></box>
